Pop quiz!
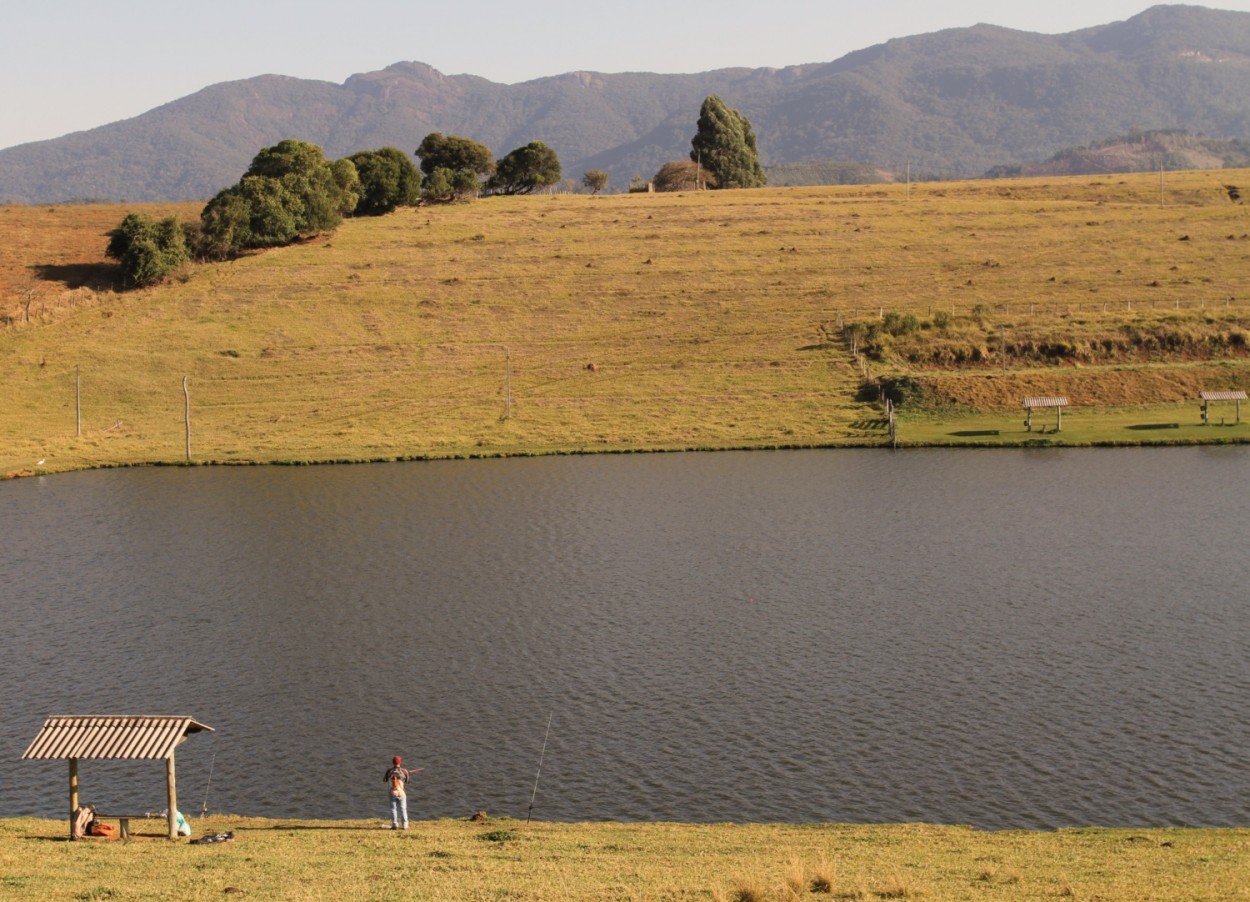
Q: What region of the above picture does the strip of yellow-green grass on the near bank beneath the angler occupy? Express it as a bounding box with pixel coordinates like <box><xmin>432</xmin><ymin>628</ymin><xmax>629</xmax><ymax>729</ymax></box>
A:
<box><xmin>0</xmin><ymin>816</ymin><xmax>1250</xmax><ymax>902</ymax></box>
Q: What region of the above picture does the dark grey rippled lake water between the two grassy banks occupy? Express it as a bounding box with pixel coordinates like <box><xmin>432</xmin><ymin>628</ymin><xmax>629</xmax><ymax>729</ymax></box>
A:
<box><xmin>0</xmin><ymin>449</ymin><xmax>1250</xmax><ymax>828</ymax></box>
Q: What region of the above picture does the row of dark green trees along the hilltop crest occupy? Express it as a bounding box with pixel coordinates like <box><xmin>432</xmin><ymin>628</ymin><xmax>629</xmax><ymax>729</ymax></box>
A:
<box><xmin>105</xmin><ymin>96</ymin><xmax>765</xmax><ymax>286</ymax></box>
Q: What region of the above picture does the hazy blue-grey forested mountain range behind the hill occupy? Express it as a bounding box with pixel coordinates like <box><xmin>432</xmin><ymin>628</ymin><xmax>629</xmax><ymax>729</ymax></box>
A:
<box><xmin>0</xmin><ymin>5</ymin><xmax>1250</xmax><ymax>204</ymax></box>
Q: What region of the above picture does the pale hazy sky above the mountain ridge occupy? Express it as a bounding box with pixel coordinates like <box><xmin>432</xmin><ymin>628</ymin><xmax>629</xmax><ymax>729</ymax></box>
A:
<box><xmin>0</xmin><ymin>0</ymin><xmax>1250</xmax><ymax>149</ymax></box>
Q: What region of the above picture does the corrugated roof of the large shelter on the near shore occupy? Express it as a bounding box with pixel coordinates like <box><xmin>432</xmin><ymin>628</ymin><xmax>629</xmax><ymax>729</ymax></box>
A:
<box><xmin>21</xmin><ymin>715</ymin><xmax>213</xmax><ymax>760</ymax></box>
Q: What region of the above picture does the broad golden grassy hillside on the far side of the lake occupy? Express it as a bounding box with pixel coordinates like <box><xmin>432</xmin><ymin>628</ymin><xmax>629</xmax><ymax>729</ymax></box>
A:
<box><xmin>0</xmin><ymin>170</ymin><xmax>1250</xmax><ymax>475</ymax></box>
